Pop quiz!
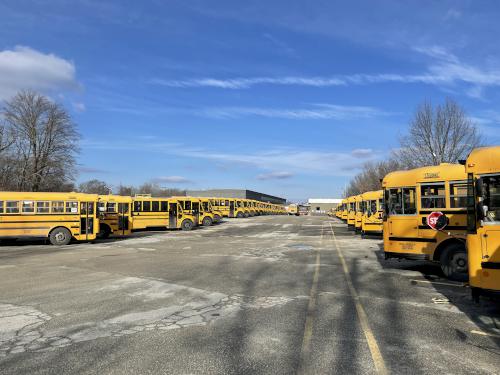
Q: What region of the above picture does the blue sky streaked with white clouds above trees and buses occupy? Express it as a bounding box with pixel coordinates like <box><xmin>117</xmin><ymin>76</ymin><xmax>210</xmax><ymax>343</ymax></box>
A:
<box><xmin>0</xmin><ymin>0</ymin><xmax>500</xmax><ymax>200</ymax></box>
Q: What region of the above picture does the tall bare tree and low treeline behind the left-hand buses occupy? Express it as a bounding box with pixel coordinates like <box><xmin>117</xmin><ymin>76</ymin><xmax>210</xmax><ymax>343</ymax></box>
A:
<box><xmin>0</xmin><ymin>90</ymin><xmax>186</xmax><ymax>196</ymax></box>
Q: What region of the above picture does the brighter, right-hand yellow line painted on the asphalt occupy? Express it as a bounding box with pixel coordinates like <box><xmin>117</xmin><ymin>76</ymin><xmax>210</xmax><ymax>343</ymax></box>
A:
<box><xmin>330</xmin><ymin>223</ymin><xmax>389</xmax><ymax>374</ymax></box>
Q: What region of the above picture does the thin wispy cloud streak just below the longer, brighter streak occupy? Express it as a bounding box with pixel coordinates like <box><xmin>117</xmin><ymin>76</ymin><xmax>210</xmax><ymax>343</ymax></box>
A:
<box><xmin>196</xmin><ymin>104</ymin><xmax>392</xmax><ymax>120</ymax></box>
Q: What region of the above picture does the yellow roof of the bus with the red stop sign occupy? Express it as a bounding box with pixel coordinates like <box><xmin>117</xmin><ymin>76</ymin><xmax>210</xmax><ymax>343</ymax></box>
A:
<box><xmin>382</xmin><ymin>163</ymin><xmax>467</xmax><ymax>188</ymax></box>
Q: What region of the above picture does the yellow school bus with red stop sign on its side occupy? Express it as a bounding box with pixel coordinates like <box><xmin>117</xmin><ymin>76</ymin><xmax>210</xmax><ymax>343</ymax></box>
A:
<box><xmin>382</xmin><ymin>163</ymin><xmax>468</xmax><ymax>280</ymax></box>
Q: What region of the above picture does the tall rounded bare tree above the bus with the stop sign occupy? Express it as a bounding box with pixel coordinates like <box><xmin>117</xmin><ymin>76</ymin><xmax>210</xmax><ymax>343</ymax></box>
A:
<box><xmin>394</xmin><ymin>99</ymin><xmax>481</xmax><ymax>168</ymax></box>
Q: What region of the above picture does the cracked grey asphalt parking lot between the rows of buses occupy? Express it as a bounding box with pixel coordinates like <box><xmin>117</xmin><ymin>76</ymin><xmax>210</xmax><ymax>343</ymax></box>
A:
<box><xmin>0</xmin><ymin>216</ymin><xmax>500</xmax><ymax>374</ymax></box>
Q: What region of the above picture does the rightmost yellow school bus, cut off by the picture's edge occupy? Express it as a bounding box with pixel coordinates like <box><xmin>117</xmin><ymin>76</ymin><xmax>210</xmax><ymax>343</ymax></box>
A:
<box><xmin>465</xmin><ymin>146</ymin><xmax>500</xmax><ymax>299</ymax></box>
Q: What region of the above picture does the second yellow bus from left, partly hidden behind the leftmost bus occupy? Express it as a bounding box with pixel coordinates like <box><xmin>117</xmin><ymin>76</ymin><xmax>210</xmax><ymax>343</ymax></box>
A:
<box><xmin>98</xmin><ymin>195</ymin><xmax>133</xmax><ymax>238</ymax></box>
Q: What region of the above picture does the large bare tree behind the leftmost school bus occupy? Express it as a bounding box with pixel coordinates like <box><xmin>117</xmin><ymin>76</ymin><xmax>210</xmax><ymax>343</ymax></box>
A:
<box><xmin>2</xmin><ymin>91</ymin><xmax>79</xmax><ymax>191</ymax></box>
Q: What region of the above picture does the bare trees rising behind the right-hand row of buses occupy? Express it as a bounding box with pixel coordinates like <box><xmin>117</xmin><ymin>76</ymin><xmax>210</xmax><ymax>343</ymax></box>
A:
<box><xmin>344</xmin><ymin>99</ymin><xmax>482</xmax><ymax>197</ymax></box>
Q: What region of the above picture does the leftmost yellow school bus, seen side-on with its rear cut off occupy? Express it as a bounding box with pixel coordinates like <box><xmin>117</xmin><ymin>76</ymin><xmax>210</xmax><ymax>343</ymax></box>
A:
<box><xmin>0</xmin><ymin>192</ymin><xmax>99</xmax><ymax>245</ymax></box>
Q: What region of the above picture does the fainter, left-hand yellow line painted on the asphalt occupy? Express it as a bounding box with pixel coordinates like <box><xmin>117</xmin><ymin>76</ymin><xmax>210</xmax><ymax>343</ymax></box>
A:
<box><xmin>297</xmin><ymin>226</ymin><xmax>324</xmax><ymax>374</ymax></box>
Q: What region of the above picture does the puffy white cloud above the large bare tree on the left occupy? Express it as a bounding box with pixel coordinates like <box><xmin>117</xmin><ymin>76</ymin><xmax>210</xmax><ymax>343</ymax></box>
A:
<box><xmin>0</xmin><ymin>46</ymin><xmax>79</xmax><ymax>99</ymax></box>
